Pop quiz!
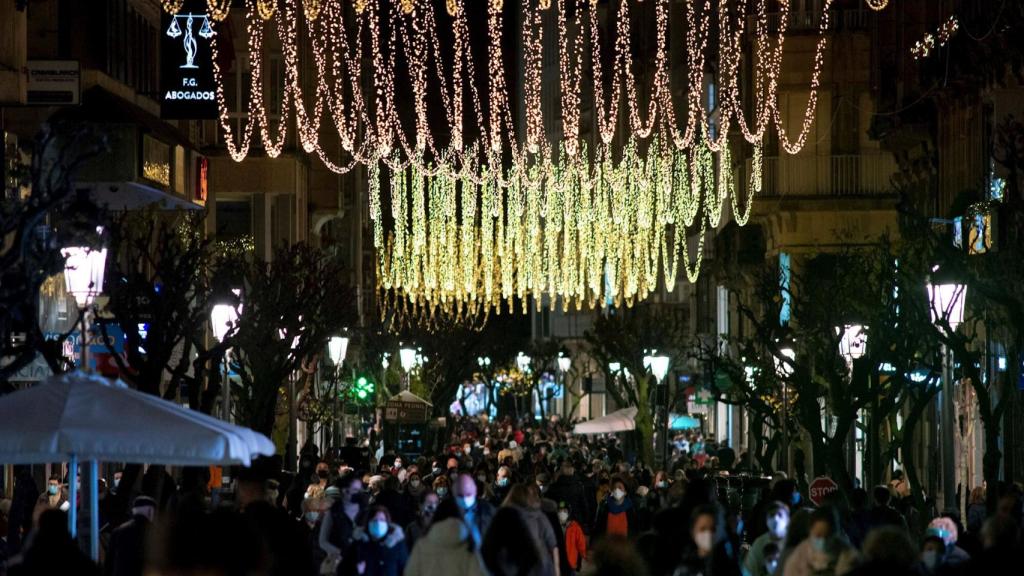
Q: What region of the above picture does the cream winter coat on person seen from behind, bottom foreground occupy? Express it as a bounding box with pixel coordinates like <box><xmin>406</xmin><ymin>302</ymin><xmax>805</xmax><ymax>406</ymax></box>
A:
<box><xmin>404</xmin><ymin>518</ymin><xmax>485</xmax><ymax>576</ymax></box>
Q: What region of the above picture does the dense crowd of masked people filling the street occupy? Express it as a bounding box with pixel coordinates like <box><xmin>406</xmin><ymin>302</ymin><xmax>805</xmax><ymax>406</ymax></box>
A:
<box><xmin>0</xmin><ymin>412</ymin><xmax>1024</xmax><ymax>576</ymax></box>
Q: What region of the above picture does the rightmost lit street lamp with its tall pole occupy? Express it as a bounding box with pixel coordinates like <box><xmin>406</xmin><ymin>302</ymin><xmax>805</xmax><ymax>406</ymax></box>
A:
<box><xmin>926</xmin><ymin>280</ymin><xmax>967</xmax><ymax>507</ymax></box>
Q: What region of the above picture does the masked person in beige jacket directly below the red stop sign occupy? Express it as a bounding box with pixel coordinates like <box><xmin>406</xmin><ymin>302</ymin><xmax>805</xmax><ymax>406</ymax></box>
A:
<box><xmin>782</xmin><ymin>506</ymin><xmax>856</xmax><ymax>576</ymax></box>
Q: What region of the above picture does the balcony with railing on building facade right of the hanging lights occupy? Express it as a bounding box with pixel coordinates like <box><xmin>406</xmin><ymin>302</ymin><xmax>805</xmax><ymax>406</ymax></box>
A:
<box><xmin>737</xmin><ymin>154</ymin><xmax>896</xmax><ymax>198</ymax></box>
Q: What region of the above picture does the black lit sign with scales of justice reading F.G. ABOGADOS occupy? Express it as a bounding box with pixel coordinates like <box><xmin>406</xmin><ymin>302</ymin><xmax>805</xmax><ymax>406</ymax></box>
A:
<box><xmin>160</xmin><ymin>0</ymin><xmax>217</xmax><ymax>120</ymax></box>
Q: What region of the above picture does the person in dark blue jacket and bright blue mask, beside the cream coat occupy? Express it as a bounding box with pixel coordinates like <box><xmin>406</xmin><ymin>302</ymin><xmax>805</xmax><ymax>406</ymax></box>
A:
<box><xmin>345</xmin><ymin>506</ymin><xmax>409</xmax><ymax>576</ymax></box>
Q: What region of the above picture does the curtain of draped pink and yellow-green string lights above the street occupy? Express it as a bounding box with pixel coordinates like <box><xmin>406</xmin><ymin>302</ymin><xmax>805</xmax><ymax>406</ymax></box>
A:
<box><xmin>188</xmin><ymin>0</ymin><xmax>831</xmax><ymax>314</ymax></box>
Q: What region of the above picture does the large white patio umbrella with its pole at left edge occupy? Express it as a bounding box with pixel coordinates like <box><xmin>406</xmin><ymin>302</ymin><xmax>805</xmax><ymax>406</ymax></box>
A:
<box><xmin>0</xmin><ymin>372</ymin><xmax>274</xmax><ymax>550</ymax></box>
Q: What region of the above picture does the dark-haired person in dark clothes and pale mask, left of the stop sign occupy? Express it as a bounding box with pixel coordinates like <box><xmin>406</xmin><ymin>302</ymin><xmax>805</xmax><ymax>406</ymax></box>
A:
<box><xmin>673</xmin><ymin>503</ymin><xmax>740</xmax><ymax>576</ymax></box>
